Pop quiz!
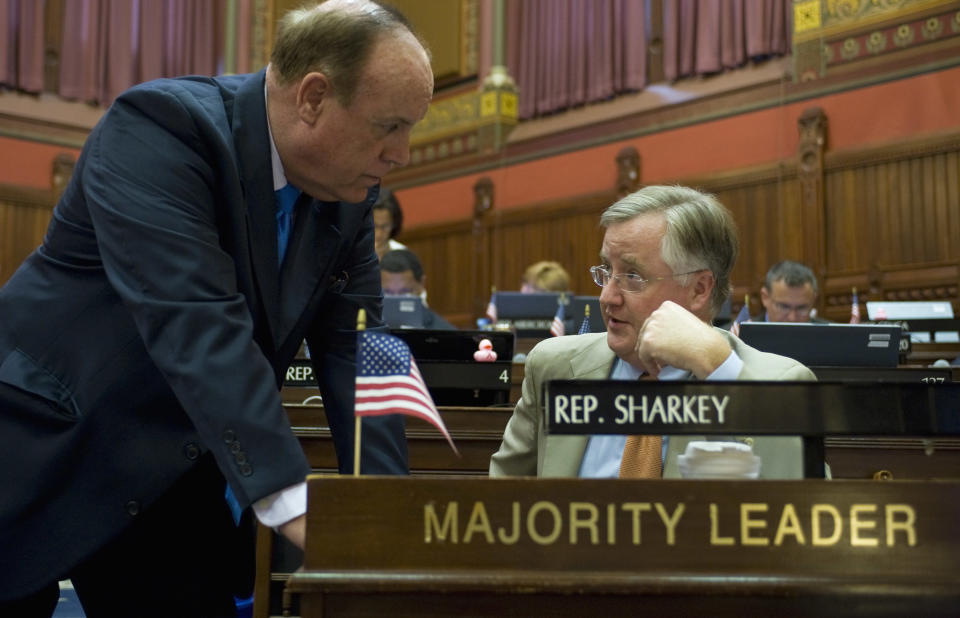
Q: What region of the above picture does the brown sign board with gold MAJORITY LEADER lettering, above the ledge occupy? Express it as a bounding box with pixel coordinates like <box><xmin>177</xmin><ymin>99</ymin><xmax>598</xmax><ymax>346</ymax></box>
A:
<box><xmin>304</xmin><ymin>476</ymin><xmax>960</xmax><ymax>578</ymax></box>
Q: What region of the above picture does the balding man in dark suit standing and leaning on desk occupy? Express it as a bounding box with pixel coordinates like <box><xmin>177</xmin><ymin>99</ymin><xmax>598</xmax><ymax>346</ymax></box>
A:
<box><xmin>0</xmin><ymin>0</ymin><xmax>433</xmax><ymax>618</ymax></box>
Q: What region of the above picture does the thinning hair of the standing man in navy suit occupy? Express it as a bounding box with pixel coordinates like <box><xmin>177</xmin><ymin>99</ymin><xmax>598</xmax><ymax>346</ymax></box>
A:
<box><xmin>270</xmin><ymin>2</ymin><xmax>426</xmax><ymax>106</ymax></box>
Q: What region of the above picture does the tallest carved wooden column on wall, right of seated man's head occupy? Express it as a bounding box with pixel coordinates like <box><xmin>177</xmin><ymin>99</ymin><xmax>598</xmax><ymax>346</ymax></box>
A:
<box><xmin>797</xmin><ymin>107</ymin><xmax>827</xmax><ymax>286</ymax></box>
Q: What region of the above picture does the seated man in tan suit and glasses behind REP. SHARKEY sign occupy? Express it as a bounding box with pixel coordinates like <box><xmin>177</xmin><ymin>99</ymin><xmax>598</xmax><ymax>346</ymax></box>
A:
<box><xmin>490</xmin><ymin>186</ymin><xmax>815</xmax><ymax>479</ymax></box>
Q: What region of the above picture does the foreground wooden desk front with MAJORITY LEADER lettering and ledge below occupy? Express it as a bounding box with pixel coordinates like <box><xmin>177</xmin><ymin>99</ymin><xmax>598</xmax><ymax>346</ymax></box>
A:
<box><xmin>288</xmin><ymin>477</ymin><xmax>960</xmax><ymax>618</ymax></box>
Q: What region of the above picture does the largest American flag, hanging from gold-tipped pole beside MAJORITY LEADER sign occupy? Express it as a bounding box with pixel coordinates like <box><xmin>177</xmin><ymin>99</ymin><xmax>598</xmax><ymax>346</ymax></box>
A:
<box><xmin>355</xmin><ymin>331</ymin><xmax>460</xmax><ymax>455</ymax></box>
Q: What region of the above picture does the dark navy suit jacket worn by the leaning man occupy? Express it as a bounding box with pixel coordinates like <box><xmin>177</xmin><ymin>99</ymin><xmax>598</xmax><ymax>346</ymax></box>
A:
<box><xmin>0</xmin><ymin>71</ymin><xmax>407</xmax><ymax>599</ymax></box>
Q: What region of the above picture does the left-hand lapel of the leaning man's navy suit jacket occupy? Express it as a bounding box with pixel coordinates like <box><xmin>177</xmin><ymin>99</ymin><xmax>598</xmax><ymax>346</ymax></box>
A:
<box><xmin>233</xmin><ymin>71</ymin><xmax>281</xmax><ymax>348</ymax></box>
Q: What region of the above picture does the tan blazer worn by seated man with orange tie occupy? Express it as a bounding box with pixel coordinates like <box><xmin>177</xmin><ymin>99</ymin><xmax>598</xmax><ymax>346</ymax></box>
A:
<box><xmin>490</xmin><ymin>328</ymin><xmax>816</xmax><ymax>479</ymax></box>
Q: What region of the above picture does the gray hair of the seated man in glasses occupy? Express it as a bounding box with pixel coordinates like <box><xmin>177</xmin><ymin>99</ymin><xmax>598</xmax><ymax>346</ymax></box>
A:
<box><xmin>600</xmin><ymin>185</ymin><xmax>740</xmax><ymax>315</ymax></box>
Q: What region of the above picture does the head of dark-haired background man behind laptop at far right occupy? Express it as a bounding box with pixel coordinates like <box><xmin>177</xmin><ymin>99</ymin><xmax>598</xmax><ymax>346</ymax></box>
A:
<box><xmin>754</xmin><ymin>260</ymin><xmax>828</xmax><ymax>324</ymax></box>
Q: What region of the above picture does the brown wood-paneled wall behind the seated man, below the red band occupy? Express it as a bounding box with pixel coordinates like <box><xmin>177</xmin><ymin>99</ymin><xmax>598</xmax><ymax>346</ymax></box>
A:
<box><xmin>402</xmin><ymin>114</ymin><xmax>960</xmax><ymax>327</ymax></box>
